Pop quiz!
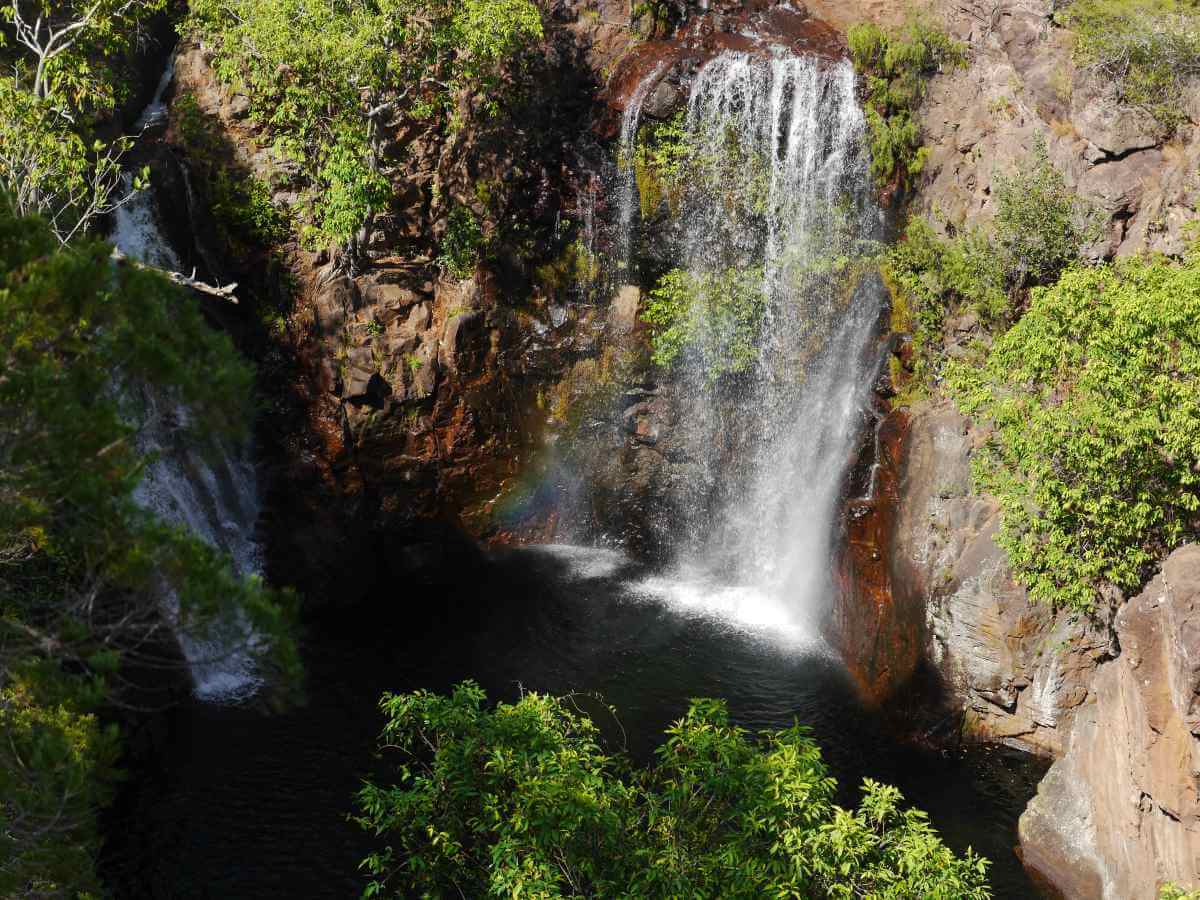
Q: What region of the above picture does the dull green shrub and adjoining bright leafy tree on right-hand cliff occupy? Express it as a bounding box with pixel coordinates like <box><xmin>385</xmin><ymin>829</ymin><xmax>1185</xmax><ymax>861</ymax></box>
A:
<box><xmin>887</xmin><ymin>132</ymin><xmax>1200</xmax><ymax>611</ymax></box>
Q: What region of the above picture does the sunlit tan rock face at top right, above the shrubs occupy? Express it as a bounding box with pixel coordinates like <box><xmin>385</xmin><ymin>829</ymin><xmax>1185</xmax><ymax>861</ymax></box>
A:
<box><xmin>916</xmin><ymin>0</ymin><xmax>1200</xmax><ymax>257</ymax></box>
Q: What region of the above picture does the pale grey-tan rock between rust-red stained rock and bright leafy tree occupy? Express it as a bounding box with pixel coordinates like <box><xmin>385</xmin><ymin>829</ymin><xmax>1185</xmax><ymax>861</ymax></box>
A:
<box><xmin>892</xmin><ymin>403</ymin><xmax>1111</xmax><ymax>754</ymax></box>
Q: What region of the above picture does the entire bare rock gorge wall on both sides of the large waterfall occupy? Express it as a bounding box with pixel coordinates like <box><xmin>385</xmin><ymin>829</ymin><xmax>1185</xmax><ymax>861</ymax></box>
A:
<box><xmin>157</xmin><ymin>0</ymin><xmax>1200</xmax><ymax>898</ymax></box>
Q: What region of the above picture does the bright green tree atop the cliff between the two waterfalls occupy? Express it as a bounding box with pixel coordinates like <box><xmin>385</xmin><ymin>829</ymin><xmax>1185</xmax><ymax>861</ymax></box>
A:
<box><xmin>185</xmin><ymin>0</ymin><xmax>542</xmax><ymax>245</ymax></box>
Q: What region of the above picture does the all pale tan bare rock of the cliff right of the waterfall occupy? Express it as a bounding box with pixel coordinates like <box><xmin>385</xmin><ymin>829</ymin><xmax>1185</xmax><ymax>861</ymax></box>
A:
<box><xmin>892</xmin><ymin>1</ymin><xmax>1200</xmax><ymax>898</ymax></box>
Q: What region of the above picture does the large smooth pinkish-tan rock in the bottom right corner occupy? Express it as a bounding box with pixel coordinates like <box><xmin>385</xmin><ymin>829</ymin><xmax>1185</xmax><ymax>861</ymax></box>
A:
<box><xmin>1020</xmin><ymin>545</ymin><xmax>1200</xmax><ymax>900</ymax></box>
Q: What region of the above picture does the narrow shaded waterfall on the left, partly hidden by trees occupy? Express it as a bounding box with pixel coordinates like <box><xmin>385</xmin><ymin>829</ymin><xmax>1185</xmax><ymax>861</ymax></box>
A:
<box><xmin>109</xmin><ymin>62</ymin><xmax>262</xmax><ymax>702</ymax></box>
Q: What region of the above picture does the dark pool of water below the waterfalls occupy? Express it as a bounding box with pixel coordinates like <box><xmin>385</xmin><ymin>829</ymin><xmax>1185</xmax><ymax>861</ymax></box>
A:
<box><xmin>104</xmin><ymin>551</ymin><xmax>1051</xmax><ymax>900</ymax></box>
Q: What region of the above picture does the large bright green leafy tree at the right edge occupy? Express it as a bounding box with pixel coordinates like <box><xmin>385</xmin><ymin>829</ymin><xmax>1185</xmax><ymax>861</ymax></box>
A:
<box><xmin>947</xmin><ymin>251</ymin><xmax>1200</xmax><ymax>610</ymax></box>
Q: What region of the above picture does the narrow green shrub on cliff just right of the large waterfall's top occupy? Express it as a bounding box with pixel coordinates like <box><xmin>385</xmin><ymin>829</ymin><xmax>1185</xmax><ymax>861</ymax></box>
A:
<box><xmin>847</xmin><ymin>18</ymin><xmax>966</xmax><ymax>190</ymax></box>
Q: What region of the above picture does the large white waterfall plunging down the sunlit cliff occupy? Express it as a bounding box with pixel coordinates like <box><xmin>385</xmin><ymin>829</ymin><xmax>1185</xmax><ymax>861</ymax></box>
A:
<box><xmin>623</xmin><ymin>53</ymin><xmax>881</xmax><ymax>637</ymax></box>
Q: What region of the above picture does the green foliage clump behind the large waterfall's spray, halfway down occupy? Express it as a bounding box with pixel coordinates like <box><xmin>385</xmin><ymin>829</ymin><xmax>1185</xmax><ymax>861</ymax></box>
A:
<box><xmin>642</xmin><ymin>268</ymin><xmax>767</xmax><ymax>380</ymax></box>
